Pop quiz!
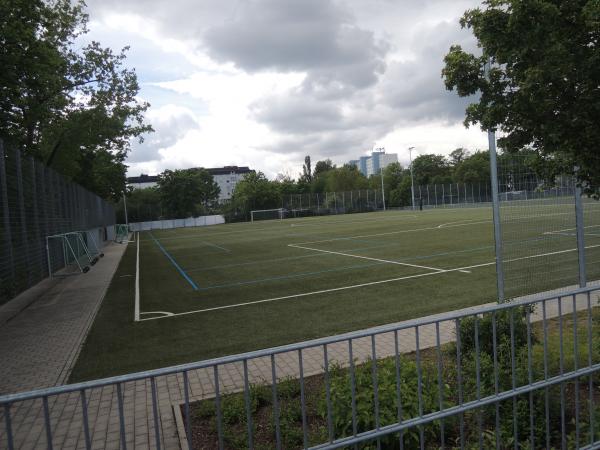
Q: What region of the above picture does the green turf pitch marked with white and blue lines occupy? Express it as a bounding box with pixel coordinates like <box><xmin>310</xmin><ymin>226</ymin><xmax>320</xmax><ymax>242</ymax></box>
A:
<box><xmin>71</xmin><ymin>208</ymin><xmax>600</xmax><ymax>381</ymax></box>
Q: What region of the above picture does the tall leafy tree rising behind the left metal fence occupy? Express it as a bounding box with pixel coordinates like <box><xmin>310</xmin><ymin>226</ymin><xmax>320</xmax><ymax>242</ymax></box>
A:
<box><xmin>0</xmin><ymin>0</ymin><xmax>152</xmax><ymax>198</ymax></box>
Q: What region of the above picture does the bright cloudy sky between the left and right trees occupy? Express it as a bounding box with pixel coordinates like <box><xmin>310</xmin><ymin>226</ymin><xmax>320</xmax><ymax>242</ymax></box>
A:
<box><xmin>86</xmin><ymin>0</ymin><xmax>487</xmax><ymax>178</ymax></box>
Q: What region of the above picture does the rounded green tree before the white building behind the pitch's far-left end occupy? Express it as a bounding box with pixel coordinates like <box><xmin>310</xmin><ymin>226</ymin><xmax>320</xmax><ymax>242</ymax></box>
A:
<box><xmin>158</xmin><ymin>169</ymin><xmax>221</xmax><ymax>219</ymax></box>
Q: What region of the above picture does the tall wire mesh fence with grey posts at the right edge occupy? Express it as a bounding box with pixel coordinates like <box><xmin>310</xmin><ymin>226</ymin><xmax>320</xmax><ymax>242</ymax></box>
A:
<box><xmin>498</xmin><ymin>155</ymin><xmax>600</xmax><ymax>299</ymax></box>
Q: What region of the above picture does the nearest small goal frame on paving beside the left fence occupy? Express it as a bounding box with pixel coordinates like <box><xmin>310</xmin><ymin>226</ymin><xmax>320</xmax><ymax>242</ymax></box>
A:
<box><xmin>46</xmin><ymin>233</ymin><xmax>92</xmax><ymax>278</ymax></box>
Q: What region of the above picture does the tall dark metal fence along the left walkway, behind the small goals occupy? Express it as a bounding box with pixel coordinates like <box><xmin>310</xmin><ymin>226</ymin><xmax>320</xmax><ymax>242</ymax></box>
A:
<box><xmin>0</xmin><ymin>141</ymin><xmax>115</xmax><ymax>304</ymax></box>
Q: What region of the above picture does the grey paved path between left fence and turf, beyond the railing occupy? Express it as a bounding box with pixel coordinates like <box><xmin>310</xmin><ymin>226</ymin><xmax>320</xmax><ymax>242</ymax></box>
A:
<box><xmin>0</xmin><ymin>243</ymin><xmax>126</xmax><ymax>394</ymax></box>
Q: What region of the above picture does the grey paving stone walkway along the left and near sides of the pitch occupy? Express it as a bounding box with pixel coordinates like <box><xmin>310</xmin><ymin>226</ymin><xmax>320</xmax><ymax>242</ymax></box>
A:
<box><xmin>0</xmin><ymin>244</ymin><xmax>598</xmax><ymax>449</ymax></box>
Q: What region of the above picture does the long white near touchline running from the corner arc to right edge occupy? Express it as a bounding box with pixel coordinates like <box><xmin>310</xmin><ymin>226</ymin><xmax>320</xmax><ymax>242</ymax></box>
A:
<box><xmin>141</xmin><ymin>244</ymin><xmax>600</xmax><ymax>322</ymax></box>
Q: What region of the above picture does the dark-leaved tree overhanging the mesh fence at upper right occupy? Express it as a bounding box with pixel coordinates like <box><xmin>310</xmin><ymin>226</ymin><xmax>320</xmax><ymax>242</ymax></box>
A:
<box><xmin>442</xmin><ymin>0</ymin><xmax>600</xmax><ymax>186</ymax></box>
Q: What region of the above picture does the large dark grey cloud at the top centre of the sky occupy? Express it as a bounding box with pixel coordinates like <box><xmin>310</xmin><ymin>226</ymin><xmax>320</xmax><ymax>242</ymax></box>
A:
<box><xmin>204</xmin><ymin>0</ymin><xmax>389</xmax><ymax>88</ymax></box>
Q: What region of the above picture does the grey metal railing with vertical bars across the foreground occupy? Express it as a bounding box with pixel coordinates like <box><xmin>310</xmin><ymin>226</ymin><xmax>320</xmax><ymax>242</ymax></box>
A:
<box><xmin>0</xmin><ymin>287</ymin><xmax>600</xmax><ymax>449</ymax></box>
